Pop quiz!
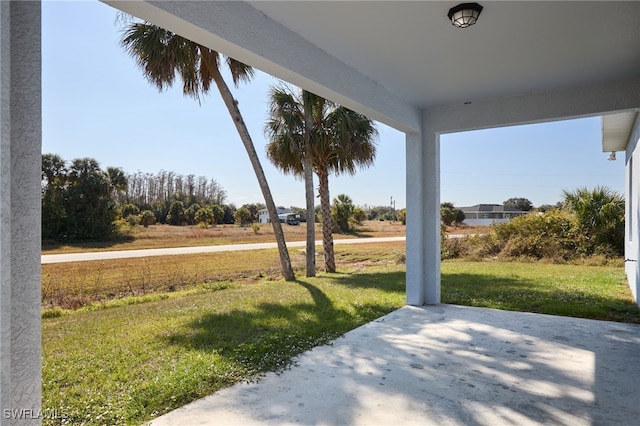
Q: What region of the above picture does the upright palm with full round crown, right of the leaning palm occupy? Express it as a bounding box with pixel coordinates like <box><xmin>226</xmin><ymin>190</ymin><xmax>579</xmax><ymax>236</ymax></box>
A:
<box><xmin>267</xmin><ymin>86</ymin><xmax>378</xmax><ymax>272</ymax></box>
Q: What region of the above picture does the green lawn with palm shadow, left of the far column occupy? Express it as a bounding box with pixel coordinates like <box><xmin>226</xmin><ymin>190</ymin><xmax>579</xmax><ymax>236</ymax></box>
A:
<box><xmin>43</xmin><ymin>266</ymin><xmax>405</xmax><ymax>425</ymax></box>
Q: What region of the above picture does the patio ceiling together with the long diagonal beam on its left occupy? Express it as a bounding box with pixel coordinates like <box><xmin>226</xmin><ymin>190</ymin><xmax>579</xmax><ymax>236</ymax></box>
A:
<box><xmin>106</xmin><ymin>0</ymin><xmax>640</xmax><ymax>135</ymax></box>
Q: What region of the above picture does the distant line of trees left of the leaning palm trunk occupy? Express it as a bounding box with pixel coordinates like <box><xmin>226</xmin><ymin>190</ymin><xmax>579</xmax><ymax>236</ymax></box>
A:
<box><xmin>41</xmin><ymin>154</ymin><xmax>251</xmax><ymax>241</ymax></box>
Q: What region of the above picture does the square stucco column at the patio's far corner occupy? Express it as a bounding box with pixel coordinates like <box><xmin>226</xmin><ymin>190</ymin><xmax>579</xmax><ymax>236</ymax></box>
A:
<box><xmin>406</xmin><ymin>128</ymin><xmax>440</xmax><ymax>306</ymax></box>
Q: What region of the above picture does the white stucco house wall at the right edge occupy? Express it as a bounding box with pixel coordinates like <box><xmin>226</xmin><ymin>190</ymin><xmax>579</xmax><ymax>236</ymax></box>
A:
<box><xmin>624</xmin><ymin>114</ymin><xmax>640</xmax><ymax>306</ymax></box>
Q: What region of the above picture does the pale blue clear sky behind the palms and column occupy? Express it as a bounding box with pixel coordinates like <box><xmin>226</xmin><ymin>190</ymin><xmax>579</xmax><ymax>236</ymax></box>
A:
<box><xmin>42</xmin><ymin>0</ymin><xmax>624</xmax><ymax>208</ymax></box>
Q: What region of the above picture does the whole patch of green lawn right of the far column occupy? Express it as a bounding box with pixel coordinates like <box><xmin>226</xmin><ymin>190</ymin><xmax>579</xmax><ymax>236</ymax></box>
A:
<box><xmin>442</xmin><ymin>261</ymin><xmax>640</xmax><ymax>323</ymax></box>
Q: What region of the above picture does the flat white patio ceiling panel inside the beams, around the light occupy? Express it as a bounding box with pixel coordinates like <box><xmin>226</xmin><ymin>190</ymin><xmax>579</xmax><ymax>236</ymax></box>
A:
<box><xmin>250</xmin><ymin>1</ymin><xmax>640</xmax><ymax>108</ymax></box>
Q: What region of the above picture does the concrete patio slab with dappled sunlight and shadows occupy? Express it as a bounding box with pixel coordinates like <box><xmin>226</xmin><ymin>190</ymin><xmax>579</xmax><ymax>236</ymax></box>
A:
<box><xmin>152</xmin><ymin>305</ymin><xmax>640</xmax><ymax>426</ymax></box>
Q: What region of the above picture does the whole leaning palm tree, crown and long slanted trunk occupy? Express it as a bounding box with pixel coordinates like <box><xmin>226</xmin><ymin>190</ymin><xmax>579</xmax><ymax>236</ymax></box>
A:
<box><xmin>121</xmin><ymin>22</ymin><xmax>295</xmax><ymax>281</ymax></box>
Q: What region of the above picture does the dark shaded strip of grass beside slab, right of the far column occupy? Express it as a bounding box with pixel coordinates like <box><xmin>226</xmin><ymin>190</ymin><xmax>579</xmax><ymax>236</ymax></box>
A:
<box><xmin>442</xmin><ymin>274</ymin><xmax>640</xmax><ymax>323</ymax></box>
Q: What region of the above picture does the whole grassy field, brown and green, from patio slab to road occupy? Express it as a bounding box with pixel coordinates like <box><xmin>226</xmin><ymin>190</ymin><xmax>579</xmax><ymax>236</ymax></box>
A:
<box><xmin>42</xmin><ymin>223</ymin><xmax>640</xmax><ymax>425</ymax></box>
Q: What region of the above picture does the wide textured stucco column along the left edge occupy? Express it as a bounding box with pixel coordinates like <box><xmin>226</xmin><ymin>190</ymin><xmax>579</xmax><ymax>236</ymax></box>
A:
<box><xmin>0</xmin><ymin>1</ymin><xmax>42</xmax><ymax>425</ymax></box>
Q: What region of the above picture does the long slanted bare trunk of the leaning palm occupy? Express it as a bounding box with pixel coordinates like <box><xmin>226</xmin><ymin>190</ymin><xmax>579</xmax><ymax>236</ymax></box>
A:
<box><xmin>207</xmin><ymin>64</ymin><xmax>296</xmax><ymax>281</ymax></box>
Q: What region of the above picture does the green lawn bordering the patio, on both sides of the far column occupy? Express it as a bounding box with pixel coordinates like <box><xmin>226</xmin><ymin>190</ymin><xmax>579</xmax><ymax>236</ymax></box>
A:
<box><xmin>43</xmin><ymin>262</ymin><xmax>640</xmax><ymax>425</ymax></box>
